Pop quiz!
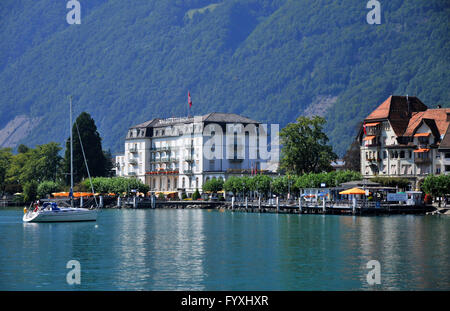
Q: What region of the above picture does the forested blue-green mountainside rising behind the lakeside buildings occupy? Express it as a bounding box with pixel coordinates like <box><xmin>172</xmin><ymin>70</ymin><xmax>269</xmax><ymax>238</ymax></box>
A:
<box><xmin>0</xmin><ymin>0</ymin><xmax>450</xmax><ymax>155</ymax></box>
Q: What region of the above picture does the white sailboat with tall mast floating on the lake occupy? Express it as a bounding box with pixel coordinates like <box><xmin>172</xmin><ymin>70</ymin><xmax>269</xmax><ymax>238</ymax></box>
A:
<box><xmin>23</xmin><ymin>97</ymin><xmax>98</xmax><ymax>222</ymax></box>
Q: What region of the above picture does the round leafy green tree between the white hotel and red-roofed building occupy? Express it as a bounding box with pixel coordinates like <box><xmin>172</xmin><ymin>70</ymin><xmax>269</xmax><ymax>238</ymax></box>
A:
<box><xmin>280</xmin><ymin>116</ymin><xmax>337</xmax><ymax>175</ymax></box>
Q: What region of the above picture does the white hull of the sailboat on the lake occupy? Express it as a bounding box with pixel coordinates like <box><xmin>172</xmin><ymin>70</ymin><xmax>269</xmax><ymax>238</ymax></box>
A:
<box><xmin>23</xmin><ymin>208</ymin><xmax>97</xmax><ymax>222</ymax></box>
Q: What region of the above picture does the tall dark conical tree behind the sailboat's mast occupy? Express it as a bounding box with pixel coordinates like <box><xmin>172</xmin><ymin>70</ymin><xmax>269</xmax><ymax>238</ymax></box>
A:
<box><xmin>64</xmin><ymin>112</ymin><xmax>108</xmax><ymax>182</ymax></box>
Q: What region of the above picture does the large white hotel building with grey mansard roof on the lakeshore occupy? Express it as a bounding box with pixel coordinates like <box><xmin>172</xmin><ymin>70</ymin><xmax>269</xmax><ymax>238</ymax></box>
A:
<box><xmin>116</xmin><ymin>113</ymin><xmax>279</xmax><ymax>194</ymax></box>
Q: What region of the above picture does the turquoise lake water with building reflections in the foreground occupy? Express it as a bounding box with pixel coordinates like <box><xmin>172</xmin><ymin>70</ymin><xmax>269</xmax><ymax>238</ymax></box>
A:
<box><xmin>0</xmin><ymin>209</ymin><xmax>450</xmax><ymax>290</ymax></box>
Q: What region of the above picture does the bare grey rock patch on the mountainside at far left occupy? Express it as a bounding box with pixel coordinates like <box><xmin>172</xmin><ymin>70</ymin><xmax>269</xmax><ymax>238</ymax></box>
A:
<box><xmin>0</xmin><ymin>115</ymin><xmax>42</xmax><ymax>148</ymax></box>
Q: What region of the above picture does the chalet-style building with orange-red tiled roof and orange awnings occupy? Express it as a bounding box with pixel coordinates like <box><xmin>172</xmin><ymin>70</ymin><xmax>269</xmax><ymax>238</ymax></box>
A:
<box><xmin>358</xmin><ymin>96</ymin><xmax>450</xmax><ymax>188</ymax></box>
